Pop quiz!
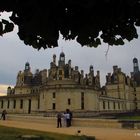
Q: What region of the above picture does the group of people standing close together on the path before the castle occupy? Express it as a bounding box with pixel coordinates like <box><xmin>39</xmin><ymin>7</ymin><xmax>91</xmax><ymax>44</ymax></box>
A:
<box><xmin>57</xmin><ymin>109</ymin><xmax>72</xmax><ymax>128</ymax></box>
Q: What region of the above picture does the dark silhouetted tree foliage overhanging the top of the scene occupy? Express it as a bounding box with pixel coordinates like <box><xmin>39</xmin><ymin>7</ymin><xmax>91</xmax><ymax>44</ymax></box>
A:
<box><xmin>0</xmin><ymin>0</ymin><xmax>140</xmax><ymax>49</ymax></box>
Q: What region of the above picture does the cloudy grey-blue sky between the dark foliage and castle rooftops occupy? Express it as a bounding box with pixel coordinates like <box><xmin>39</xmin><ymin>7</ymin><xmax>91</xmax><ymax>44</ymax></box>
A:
<box><xmin>0</xmin><ymin>14</ymin><xmax>140</xmax><ymax>95</ymax></box>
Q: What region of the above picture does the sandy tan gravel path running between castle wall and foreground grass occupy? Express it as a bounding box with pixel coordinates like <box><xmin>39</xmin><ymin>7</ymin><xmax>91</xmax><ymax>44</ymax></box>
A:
<box><xmin>0</xmin><ymin>120</ymin><xmax>140</xmax><ymax>140</ymax></box>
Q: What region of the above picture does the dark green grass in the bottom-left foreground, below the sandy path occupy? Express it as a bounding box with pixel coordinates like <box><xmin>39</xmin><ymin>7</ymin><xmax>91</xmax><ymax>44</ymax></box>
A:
<box><xmin>0</xmin><ymin>126</ymin><xmax>95</xmax><ymax>140</ymax></box>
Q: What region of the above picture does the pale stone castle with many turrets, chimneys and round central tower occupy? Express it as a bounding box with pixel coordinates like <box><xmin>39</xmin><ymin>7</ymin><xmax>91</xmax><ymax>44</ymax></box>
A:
<box><xmin>0</xmin><ymin>52</ymin><xmax>140</xmax><ymax>114</ymax></box>
